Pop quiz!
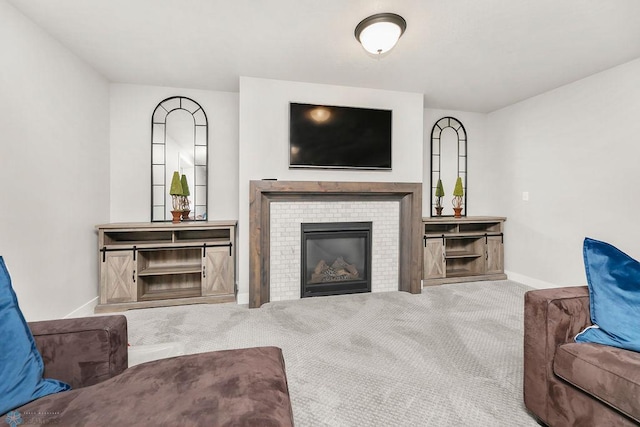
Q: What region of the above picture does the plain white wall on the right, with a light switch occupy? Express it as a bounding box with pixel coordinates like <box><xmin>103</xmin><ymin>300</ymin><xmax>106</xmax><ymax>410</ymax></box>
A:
<box><xmin>487</xmin><ymin>60</ymin><xmax>640</xmax><ymax>286</ymax></box>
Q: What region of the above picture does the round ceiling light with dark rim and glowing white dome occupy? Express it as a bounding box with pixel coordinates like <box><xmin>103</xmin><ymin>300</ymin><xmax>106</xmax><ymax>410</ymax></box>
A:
<box><xmin>355</xmin><ymin>13</ymin><xmax>407</xmax><ymax>56</ymax></box>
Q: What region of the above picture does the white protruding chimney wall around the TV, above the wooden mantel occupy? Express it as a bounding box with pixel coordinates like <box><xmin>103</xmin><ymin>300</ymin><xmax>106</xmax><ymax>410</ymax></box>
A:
<box><xmin>238</xmin><ymin>77</ymin><xmax>423</xmax><ymax>303</ymax></box>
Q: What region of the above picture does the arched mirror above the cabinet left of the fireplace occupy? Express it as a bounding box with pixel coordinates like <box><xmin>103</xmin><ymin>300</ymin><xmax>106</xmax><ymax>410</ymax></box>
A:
<box><xmin>151</xmin><ymin>96</ymin><xmax>208</xmax><ymax>221</ymax></box>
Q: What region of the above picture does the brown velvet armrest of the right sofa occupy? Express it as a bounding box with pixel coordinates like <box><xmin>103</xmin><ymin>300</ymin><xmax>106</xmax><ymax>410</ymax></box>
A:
<box><xmin>524</xmin><ymin>286</ymin><xmax>591</xmax><ymax>422</ymax></box>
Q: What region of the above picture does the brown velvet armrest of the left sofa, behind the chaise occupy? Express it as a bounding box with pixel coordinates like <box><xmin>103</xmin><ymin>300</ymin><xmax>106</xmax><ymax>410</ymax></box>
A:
<box><xmin>29</xmin><ymin>315</ymin><xmax>128</xmax><ymax>388</ymax></box>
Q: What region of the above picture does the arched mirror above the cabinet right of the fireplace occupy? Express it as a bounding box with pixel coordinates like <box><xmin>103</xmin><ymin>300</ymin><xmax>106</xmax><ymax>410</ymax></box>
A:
<box><xmin>431</xmin><ymin>117</ymin><xmax>467</xmax><ymax>216</ymax></box>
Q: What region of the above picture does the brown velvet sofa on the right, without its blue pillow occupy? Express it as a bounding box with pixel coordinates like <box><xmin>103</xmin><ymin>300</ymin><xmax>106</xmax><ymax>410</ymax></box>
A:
<box><xmin>524</xmin><ymin>286</ymin><xmax>640</xmax><ymax>427</ymax></box>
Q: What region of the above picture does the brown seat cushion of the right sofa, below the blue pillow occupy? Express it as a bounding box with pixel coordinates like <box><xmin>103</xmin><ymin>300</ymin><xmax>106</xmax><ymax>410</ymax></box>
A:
<box><xmin>553</xmin><ymin>343</ymin><xmax>640</xmax><ymax>422</ymax></box>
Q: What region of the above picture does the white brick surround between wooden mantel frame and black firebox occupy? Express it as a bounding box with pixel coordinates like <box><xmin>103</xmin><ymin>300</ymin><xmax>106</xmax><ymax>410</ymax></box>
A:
<box><xmin>270</xmin><ymin>201</ymin><xmax>400</xmax><ymax>301</ymax></box>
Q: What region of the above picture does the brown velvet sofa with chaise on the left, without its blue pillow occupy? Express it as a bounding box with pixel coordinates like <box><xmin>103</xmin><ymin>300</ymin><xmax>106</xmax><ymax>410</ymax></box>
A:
<box><xmin>16</xmin><ymin>315</ymin><xmax>293</xmax><ymax>426</ymax></box>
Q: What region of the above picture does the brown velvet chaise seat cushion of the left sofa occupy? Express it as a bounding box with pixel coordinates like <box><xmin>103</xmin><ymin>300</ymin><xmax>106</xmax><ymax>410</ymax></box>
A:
<box><xmin>18</xmin><ymin>347</ymin><xmax>293</xmax><ymax>427</ymax></box>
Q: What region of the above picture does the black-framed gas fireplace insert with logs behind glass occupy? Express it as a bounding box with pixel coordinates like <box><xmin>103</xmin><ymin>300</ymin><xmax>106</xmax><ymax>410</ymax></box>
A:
<box><xmin>300</xmin><ymin>222</ymin><xmax>372</xmax><ymax>298</ymax></box>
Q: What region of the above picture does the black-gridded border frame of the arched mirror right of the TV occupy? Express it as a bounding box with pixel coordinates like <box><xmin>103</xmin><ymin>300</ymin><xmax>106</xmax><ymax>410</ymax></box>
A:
<box><xmin>429</xmin><ymin>116</ymin><xmax>469</xmax><ymax>217</ymax></box>
